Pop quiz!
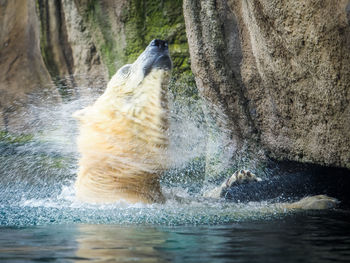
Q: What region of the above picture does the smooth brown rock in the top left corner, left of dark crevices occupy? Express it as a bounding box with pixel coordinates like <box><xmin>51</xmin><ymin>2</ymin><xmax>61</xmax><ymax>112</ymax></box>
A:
<box><xmin>0</xmin><ymin>0</ymin><xmax>55</xmax><ymax>131</ymax></box>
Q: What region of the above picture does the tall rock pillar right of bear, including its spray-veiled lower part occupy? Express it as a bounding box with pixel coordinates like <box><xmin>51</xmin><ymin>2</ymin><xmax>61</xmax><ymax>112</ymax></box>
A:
<box><xmin>183</xmin><ymin>0</ymin><xmax>257</xmax><ymax>181</ymax></box>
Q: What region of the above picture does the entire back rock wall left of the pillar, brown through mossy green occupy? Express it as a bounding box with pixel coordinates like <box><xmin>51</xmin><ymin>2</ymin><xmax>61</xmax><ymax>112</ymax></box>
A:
<box><xmin>0</xmin><ymin>0</ymin><xmax>192</xmax><ymax>132</ymax></box>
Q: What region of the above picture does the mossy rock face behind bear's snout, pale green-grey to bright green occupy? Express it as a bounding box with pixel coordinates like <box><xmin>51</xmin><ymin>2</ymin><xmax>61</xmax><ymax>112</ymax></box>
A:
<box><xmin>77</xmin><ymin>0</ymin><xmax>191</xmax><ymax>80</ymax></box>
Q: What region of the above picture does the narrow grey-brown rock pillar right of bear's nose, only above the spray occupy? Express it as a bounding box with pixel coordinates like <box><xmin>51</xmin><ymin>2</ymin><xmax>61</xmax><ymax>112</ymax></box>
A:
<box><xmin>183</xmin><ymin>0</ymin><xmax>254</xmax><ymax>148</ymax></box>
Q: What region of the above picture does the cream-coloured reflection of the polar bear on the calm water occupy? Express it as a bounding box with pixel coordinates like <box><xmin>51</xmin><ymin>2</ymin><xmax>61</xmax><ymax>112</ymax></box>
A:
<box><xmin>75</xmin><ymin>225</ymin><xmax>168</xmax><ymax>263</ymax></box>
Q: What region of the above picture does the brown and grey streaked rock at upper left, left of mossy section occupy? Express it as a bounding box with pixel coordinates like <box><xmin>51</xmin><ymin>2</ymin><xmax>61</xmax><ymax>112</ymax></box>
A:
<box><xmin>0</xmin><ymin>0</ymin><xmax>107</xmax><ymax>133</ymax></box>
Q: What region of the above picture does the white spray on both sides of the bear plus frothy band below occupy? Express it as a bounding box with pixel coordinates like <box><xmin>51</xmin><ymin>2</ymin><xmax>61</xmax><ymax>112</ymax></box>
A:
<box><xmin>0</xmin><ymin>75</ymin><xmax>279</xmax><ymax>226</ymax></box>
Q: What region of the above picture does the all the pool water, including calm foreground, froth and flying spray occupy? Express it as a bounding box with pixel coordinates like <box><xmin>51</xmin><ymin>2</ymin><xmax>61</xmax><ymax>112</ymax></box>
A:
<box><xmin>0</xmin><ymin>90</ymin><xmax>350</xmax><ymax>262</ymax></box>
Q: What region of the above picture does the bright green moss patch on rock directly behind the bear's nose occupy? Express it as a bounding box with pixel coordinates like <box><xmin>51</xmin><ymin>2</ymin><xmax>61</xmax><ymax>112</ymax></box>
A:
<box><xmin>125</xmin><ymin>0</ymin><xmax>190</xmax><ymax>75</ymax></box>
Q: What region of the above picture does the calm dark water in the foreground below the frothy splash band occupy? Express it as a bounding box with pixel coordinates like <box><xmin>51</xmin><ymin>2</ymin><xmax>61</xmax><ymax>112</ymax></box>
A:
<box><xmin>0</xmin><ymin>210</ymin><xmax>350</xmax><ymax>263</ymax></box>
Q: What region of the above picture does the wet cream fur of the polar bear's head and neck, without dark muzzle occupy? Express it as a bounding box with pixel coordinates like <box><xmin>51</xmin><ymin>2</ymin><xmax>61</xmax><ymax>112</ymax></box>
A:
<box><xmin>74</xmin><ymin>68</ymin><xmax>169</xmax><ymax>203</ymax></box>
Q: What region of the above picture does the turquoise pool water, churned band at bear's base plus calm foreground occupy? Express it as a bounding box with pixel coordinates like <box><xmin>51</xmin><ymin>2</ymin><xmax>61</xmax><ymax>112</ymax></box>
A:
<box><xmin>0</xmin><ymin>167</ymin><xmax>350</xmax><ymax>262</ymax></box>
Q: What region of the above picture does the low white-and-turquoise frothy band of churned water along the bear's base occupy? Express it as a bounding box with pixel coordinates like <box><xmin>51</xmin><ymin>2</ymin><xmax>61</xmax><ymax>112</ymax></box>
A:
<box><xmin>0</xmin><ymin>183</ymin><xmax>290</xmax><ymax>226</ymax></box>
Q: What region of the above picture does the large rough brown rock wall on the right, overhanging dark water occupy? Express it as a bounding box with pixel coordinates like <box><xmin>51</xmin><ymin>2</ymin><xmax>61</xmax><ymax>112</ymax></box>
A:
<box><xmin>232</xmin><ymin>0</ymin><xmax>350</xmax><ymax>168</ymax></box>
